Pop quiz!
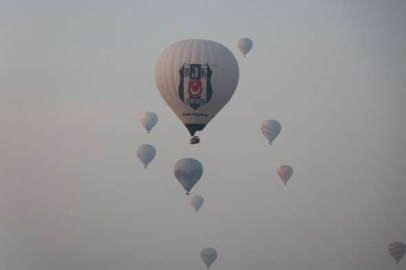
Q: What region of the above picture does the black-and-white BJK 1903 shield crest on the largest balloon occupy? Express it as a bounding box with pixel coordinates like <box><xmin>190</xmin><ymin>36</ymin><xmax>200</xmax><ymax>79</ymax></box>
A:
<box><xmin>179</xmin><ymin>64</ymin><xmax>213</xmax><ymax>110</ymax></box>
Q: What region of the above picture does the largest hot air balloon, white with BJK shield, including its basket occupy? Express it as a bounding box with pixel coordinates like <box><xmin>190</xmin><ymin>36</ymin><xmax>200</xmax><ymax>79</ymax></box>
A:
<box><xmin>155</xmin><ymin>39</ymin><xmax>239</xmax><ymax>144</ymax></box>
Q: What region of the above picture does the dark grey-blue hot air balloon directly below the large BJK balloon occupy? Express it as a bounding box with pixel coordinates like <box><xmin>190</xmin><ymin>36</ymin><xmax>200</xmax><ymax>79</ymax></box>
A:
<box><xmin>174</xmin><ymin>158</ymin><xmax>203</xmax><ymax>195</ymax></box>
